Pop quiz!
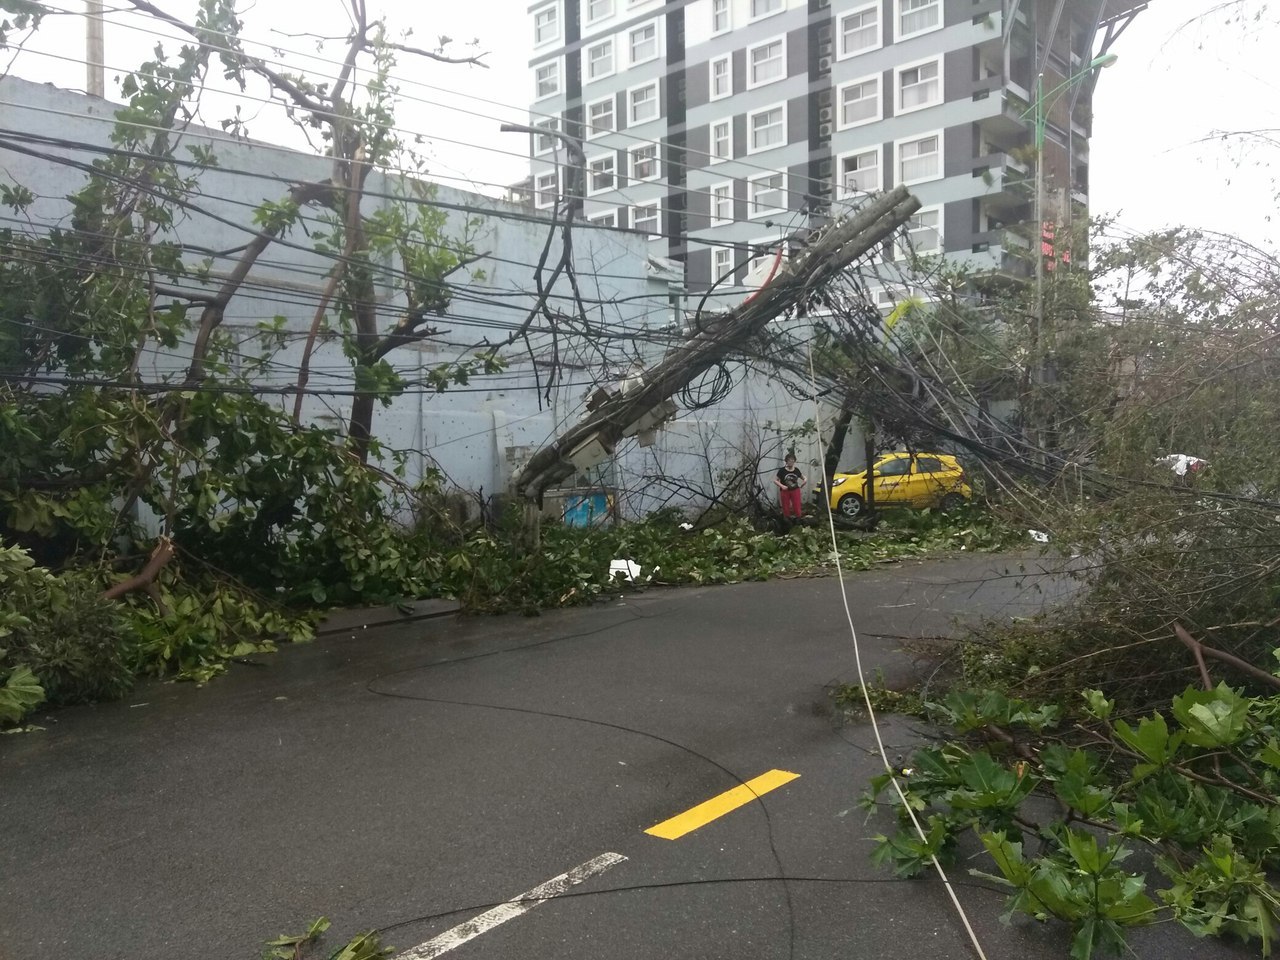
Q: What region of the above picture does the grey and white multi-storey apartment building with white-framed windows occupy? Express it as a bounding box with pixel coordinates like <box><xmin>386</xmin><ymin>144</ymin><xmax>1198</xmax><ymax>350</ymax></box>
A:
<box><xmin>529</xmin><ymin>0</ymin><xmax>1146</xmax><ymax>296</ymax></box>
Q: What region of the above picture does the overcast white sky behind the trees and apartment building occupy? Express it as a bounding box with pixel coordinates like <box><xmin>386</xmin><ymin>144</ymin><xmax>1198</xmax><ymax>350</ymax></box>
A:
<box><xmin>0</xmin><ymin>0</ymin><xmax>1280</xmax><ymax>246</ymax></box>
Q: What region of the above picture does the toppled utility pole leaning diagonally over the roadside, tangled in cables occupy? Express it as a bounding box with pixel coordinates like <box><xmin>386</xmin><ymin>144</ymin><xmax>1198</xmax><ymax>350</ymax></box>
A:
<box><xmin>512</xmin><ymin>187</ymin><xmax>920</xmax><ymax>504</ymax></box>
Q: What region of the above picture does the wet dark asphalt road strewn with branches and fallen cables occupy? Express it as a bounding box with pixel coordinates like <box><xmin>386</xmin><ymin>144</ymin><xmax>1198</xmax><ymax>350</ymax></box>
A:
<box><xmin>0</xmin><ymin>557</ymin><xmax>1249</xmax><ymax>960</ymax></box>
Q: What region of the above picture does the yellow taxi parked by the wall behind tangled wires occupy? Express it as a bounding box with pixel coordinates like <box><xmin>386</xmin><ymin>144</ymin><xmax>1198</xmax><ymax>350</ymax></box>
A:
<box><xmin>813</xmin><ymin>453</ymin><xmax>973</xmax><ymax>517</ymax></box>
